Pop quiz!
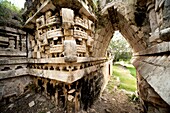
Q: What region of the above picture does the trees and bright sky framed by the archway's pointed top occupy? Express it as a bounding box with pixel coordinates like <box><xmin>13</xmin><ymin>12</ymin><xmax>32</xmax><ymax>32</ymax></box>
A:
<box><xmin>109</xmin><ymin>32</ymin><xmax>132</xmax><ymax>61</ymax></box>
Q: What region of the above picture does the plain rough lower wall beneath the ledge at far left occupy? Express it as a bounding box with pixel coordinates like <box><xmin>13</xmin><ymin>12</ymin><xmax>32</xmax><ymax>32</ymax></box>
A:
<box><xmin>0</xmin><ymin>73</ymin><xmax>33</xmax><ymax>106</ymax></box>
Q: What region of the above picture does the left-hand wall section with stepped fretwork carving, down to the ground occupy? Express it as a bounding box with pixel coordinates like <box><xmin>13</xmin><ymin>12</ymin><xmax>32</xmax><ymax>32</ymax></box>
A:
<box><xmin>0</xmin><ymin>26</ymin><xmax>32</xmax><ymax>105</ymax></box>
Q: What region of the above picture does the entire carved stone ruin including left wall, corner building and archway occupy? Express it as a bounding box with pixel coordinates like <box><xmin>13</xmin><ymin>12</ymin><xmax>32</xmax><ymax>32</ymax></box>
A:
<box><xmin>0</xmin><ymin>0</ymin><xmax>170</xmax><ymax>113</ymax></box>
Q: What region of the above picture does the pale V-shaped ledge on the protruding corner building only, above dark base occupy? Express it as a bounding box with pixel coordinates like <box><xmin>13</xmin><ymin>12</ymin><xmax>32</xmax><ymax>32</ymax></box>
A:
<box><xmin>29</xmin><ymin>60</ymin><xmax>105</xmax><ymax>83</ymax></box>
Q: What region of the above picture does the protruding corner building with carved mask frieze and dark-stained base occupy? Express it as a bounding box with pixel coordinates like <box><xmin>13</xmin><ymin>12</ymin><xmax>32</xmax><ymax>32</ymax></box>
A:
<box><xmin>21</xmin><ymin>0</ymin><xmax>112</xmax><ymax>113</ymax></box>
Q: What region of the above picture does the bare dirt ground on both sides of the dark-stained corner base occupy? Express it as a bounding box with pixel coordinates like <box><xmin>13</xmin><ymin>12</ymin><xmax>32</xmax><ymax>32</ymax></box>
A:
<box><xmin>0</xmin><ymin>91</ymin><xmax>142</xmax><ymax>113</ymax></box>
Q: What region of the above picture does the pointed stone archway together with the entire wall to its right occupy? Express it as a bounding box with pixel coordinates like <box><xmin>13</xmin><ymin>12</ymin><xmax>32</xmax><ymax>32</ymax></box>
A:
<box><xmin>93</xmin><ymin>0</ymin><xmax>170</xmax><ymax>113</ymax></box>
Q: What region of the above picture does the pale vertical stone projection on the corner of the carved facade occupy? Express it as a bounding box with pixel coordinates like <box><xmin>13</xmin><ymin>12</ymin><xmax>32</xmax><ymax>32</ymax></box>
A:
<box><xmin>61</xmin><ymin>8</ymin><xmax>77</xmax><ymax>62</ymax></box>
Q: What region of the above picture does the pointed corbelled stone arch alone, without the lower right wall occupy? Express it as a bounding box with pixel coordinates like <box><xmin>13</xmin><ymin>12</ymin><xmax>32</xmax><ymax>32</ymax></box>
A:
<box><xmin>93</xmin><ymin>2</ymin><xmax>147</xmax><ymax>57</ymax></box>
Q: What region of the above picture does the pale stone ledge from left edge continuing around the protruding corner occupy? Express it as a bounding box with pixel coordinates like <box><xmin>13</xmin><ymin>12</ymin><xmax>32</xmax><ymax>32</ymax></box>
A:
<box><xmin>0</xmin><ymin>61</ymin><xmax>109</xmax><ymax>83</ymax></box>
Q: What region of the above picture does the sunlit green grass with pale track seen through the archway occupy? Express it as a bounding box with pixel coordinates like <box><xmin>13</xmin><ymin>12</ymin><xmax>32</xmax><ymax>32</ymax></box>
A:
<box><xmin>108</xmin><ymin>64</ymin><xmax>137</xmax><ymax>92</ymax></box>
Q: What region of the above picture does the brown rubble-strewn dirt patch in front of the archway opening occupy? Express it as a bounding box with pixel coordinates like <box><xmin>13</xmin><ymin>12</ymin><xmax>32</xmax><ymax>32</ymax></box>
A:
<box><xmin>90</xmin><ymin>90</ymin><xmax>142</xmax><ymax>113</ymax></box>
